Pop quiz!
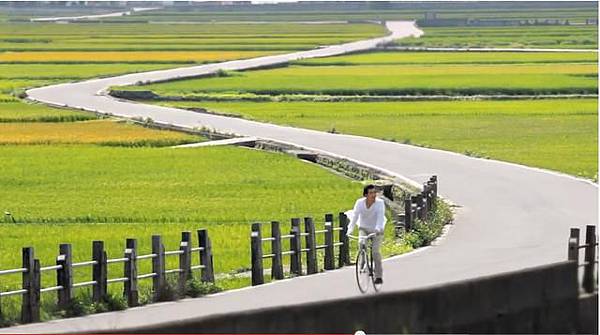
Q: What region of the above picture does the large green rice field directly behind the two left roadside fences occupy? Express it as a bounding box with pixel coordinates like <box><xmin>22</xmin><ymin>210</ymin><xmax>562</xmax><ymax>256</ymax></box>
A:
<box><xmin>0</xmin><ymin>145</ymin><xmax>404</xmax><ymax>320</ymax></box>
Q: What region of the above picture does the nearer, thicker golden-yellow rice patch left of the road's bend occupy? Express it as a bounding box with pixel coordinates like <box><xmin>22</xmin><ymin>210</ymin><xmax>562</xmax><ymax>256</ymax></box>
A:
<box><xmin>0</xmin><ymin>120</ymin><xmax>202</xmax><ymax>146</ymax></box>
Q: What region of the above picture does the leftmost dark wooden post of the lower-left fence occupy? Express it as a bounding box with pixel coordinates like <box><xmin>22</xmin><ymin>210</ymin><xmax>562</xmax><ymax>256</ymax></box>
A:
<box><xmin>21</xmin><ymin>247</ymin><xmax>40</xmax><ymax>323</ymax></box>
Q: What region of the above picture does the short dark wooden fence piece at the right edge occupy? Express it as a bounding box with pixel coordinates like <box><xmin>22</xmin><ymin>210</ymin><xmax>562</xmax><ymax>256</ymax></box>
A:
<box><xmin>568</xmin><ymin>225</ymin><xmax>598</xmax><ymax>293</ymax></box>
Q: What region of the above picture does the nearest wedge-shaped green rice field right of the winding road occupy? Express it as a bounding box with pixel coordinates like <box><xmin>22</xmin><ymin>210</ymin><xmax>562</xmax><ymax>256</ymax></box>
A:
<box><xmin>157</xmin><ymin>99</ymin><xmax>598</xmax><ymax>179</ymax></box>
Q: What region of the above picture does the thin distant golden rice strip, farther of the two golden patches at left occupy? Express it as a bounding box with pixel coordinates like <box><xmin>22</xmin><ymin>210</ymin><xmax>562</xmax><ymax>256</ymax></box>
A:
<box><xmin>0</xmin><ymin>51</ymin><xmax>277</xmax><ymax>63</ymax></box>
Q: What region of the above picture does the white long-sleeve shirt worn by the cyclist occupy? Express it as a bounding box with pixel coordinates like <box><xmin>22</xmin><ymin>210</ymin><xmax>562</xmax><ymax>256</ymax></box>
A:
<box><xmin>347</xmin><ymin>197</ymin><xmax>387</xmax><ymax>234</ymax></box>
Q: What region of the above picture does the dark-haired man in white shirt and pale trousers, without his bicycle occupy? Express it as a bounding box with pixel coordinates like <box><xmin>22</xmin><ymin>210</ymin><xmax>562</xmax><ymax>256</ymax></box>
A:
<box><xmin>346</xmin><ymin>185</ymin><xmax>386</xmax><ymax>284</ymax></box>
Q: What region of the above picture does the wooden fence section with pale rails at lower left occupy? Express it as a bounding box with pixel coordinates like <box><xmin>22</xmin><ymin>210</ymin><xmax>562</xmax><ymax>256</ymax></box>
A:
<box><xmin>0</xmin><ymin>229</ymin><xmax>214</xmax><ymax>323</ymax></box>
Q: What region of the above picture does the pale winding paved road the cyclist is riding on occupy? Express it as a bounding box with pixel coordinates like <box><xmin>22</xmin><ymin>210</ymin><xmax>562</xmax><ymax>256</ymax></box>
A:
<box><xmin>7</xmin><ymin>22</ymin><xmax>598</xmax><ymax>333</ymax></box>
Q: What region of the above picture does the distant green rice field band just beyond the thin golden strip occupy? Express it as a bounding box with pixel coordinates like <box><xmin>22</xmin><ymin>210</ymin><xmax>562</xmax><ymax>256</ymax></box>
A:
<box><xmin>0</xmin><ymin>23</ymin><xmax>384</xmax><ymax>52</ymax></box>
